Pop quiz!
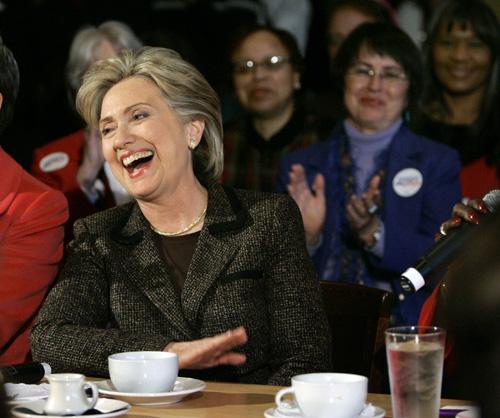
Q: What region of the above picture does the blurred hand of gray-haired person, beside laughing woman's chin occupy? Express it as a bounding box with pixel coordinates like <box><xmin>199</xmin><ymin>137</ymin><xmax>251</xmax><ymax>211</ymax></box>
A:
<box><xmin>76</xmin><ymin>127</ymin><xmax>104</xmax><ymax>193</ymax></box>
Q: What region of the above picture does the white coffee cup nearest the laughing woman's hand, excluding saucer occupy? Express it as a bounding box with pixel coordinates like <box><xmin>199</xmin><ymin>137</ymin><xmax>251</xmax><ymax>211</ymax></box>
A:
<box><xmin>108</xmin><ymin>351</ymin><xmax>179</xmax><ymax>393</ymax></box>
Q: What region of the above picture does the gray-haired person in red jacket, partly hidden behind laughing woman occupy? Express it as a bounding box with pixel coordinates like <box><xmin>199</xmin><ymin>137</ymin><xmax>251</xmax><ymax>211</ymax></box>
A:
<box><xmin>31</xmin><ymin>21</ymin><xmax>142</xmax><ymax>241</ymax></box>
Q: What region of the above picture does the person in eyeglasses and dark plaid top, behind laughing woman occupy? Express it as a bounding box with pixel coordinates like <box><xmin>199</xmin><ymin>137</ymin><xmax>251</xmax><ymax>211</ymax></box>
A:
<box><xmin>223</xmin><ymin>26</ymin><xmax>328</xmax><ymax>191</ymax></box>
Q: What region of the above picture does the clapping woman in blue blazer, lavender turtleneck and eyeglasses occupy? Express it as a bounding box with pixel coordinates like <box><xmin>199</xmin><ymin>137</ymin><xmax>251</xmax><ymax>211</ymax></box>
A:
<box><xmin>277</xmin><ymin>23</ymin><xmax>460</xmax><ymax>324</ymax></box>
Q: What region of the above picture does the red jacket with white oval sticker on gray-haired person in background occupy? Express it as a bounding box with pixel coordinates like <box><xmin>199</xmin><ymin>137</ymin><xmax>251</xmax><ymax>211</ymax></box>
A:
<box><xmin>31</xmin><ymin>129</ymin><xmax>116</xmax><ymax>240</ymax></box>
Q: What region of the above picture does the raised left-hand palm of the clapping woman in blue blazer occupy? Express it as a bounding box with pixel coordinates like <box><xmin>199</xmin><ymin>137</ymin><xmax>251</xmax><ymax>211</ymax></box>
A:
<box><xmin>287</xmin><ymin>164</ymin><xmax>326</xmax><ymax>245</ymax></box>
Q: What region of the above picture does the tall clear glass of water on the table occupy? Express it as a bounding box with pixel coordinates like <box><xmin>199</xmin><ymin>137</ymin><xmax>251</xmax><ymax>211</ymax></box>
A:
<box><xmin>385</xmin><ymin>326</ymin><xmax>446</xmax><ymax>418</ymax></box>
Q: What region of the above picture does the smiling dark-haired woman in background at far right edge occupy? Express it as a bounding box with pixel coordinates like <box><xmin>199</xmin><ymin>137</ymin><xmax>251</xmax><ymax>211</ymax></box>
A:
<box><xmin>414</xmin><ymin>0</ymin><xmax>500</xmax><ymax>198</ymax></box>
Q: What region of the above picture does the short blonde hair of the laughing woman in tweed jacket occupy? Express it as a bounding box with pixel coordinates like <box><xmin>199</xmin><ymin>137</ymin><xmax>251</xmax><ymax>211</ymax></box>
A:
<box><xmin>76</xmin><ymin>47</ymin><xmax>224</xmax><ymax>184</ymax></box>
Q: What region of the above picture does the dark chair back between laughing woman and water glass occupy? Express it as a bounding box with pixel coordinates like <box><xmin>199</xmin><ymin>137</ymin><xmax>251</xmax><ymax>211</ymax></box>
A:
<box><xmin>320</xmin><ymin>280</ymin><xmax>395</xmax><ymax>393</ymax></box>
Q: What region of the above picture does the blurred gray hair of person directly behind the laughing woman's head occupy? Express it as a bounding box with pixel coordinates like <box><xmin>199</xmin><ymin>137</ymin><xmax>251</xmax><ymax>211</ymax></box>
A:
<box><xmin>66</xmin><ymin>20</ymin><xmax>142</xmax><ymax>102</ymax></box>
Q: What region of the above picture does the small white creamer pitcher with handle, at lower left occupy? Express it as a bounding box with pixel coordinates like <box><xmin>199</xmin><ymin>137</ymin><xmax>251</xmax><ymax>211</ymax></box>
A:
<box><xmin>44</xmin><ymin>373</ymin><xmax>99</xmax><ymax>415</ymax></box>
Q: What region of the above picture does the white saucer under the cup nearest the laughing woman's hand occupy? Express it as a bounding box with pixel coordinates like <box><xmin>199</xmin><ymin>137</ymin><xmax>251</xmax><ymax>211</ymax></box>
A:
<box><xmin>94</xmin><ymin>377</ymin><xmax>206</xmax><ymax>406</ymax></box>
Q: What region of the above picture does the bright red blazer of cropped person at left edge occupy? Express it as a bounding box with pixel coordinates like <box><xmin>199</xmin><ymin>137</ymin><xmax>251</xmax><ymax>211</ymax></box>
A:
<box><xmin>0</xmin><ymin>148</ymin><xmax>68</xmax><ymax>366</ymax></box>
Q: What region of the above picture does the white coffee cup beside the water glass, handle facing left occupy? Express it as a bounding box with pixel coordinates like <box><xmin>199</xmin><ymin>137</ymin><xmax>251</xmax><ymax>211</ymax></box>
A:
<box><xmin>275</xmin><ymin>373</ymin><xmax>368</xmax><ymax>418</ymax></box>
